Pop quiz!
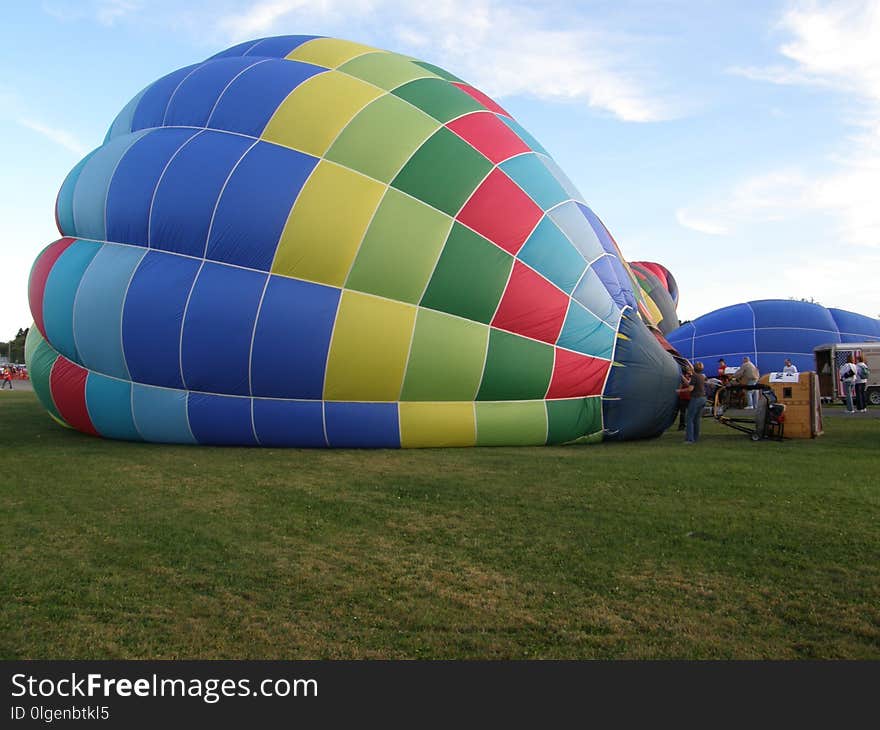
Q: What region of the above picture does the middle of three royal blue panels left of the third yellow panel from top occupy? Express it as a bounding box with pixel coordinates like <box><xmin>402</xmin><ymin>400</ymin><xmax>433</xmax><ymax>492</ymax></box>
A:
<box><xmin>149</xmin><ymin>132</ymin><xmax>254</xmax><ymax>257</ymax></box>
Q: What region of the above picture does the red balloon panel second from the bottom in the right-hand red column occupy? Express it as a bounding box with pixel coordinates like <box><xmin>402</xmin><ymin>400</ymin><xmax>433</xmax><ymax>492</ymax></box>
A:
<box><xmin>492</xmin><ymin>261</ymin><xmax>568</xmax><ymax>345</ymax></box>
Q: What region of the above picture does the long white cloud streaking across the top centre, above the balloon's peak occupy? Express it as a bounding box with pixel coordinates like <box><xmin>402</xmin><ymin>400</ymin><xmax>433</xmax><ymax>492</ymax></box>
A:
<box><xmin>216</xmin><ymin>0</ymin><xmax>680</xmax><ymax>122</ymax></box>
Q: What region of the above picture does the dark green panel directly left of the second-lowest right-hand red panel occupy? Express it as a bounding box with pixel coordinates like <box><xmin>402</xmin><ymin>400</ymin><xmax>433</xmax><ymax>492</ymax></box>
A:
<box><xmin>421</xmin><ymin>223</ymin><xmax>513</xmax><ymax>324</ymax></box>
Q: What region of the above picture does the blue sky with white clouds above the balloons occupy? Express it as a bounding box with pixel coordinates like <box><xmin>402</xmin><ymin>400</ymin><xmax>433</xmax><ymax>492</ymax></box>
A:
<box><xmin>0</xmin><ymin>0</ymin><xmax>880</xmax><ymax>342</ymax></box>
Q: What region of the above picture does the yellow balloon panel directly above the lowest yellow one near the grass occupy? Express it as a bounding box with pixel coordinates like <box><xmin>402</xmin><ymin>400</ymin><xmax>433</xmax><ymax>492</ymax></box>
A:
<box><xmin>324</xmin><ymin>291</ymin><xmax>417</xmax><ymax>401</ymax></box>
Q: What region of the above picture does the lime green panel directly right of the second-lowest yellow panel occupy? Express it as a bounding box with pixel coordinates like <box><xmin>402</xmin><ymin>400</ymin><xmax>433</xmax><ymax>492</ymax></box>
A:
<box><xmin>400</xmin><ymin>309</ymin><xmax>489</xmax><ymax>401</ymax></box>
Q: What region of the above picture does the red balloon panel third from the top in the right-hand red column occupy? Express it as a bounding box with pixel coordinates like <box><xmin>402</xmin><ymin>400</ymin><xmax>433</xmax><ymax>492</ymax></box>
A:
<box><xmin>458</xmin><ymin>167</ymin><xmax>544</xmax><ymax>255</ymax></box>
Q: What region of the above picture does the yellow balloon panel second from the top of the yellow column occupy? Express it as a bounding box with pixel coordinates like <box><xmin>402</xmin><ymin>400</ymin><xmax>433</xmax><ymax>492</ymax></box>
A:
<box><xmin>263</xmin><ymin>71</ymin><xmax>385</xmax><ymax>157</ymax></box>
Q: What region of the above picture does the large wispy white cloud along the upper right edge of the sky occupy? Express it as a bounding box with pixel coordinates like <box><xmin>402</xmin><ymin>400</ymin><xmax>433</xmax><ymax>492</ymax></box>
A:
<box><xmin>677</xmin><ymin>1</ymin><xmax>880</xmax><ymax>247</ymax></box>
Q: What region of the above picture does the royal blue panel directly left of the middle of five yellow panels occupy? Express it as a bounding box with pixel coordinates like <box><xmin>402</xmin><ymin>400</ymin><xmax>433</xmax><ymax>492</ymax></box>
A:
<box><xmin>207</xmin><ymin>142</ymin><xmax>318</xmax><ymax>271</ymax></box>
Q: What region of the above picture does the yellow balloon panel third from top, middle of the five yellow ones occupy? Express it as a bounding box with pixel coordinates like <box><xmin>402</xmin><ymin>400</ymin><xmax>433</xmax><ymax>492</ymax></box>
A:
<box><xmin>272</xmin><ymin>160</ymin><xmax>387</xmax><ymax>286</ymax></box>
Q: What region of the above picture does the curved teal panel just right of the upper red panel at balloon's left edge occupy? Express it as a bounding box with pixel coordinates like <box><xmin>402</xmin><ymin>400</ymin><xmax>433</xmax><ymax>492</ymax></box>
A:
<box><xmin>43</xmin><ymin>241</ymin><xmax>102</xmax><ymax>363</ymax></box>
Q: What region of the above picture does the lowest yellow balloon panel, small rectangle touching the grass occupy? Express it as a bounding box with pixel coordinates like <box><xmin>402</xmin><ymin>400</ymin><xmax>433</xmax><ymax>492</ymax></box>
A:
<box><xmin>400</xmin><ymin>402</ymin><xmax>477</xmax><ymax>449</ymax></box>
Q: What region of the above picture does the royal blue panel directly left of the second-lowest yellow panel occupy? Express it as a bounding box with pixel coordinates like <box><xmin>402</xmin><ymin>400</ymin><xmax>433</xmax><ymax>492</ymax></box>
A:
<box><xmin>251</xmin><ymin>276</ymin><xmax>340</xmax><ymax>400</ymax></box>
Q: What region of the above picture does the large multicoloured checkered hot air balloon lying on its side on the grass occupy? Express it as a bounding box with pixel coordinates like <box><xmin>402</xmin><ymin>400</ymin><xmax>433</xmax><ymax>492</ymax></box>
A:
<box><xmin>28</xmin><ymin>36</ymin><xmax>678</xmax><ymax>447</ymax></box>
